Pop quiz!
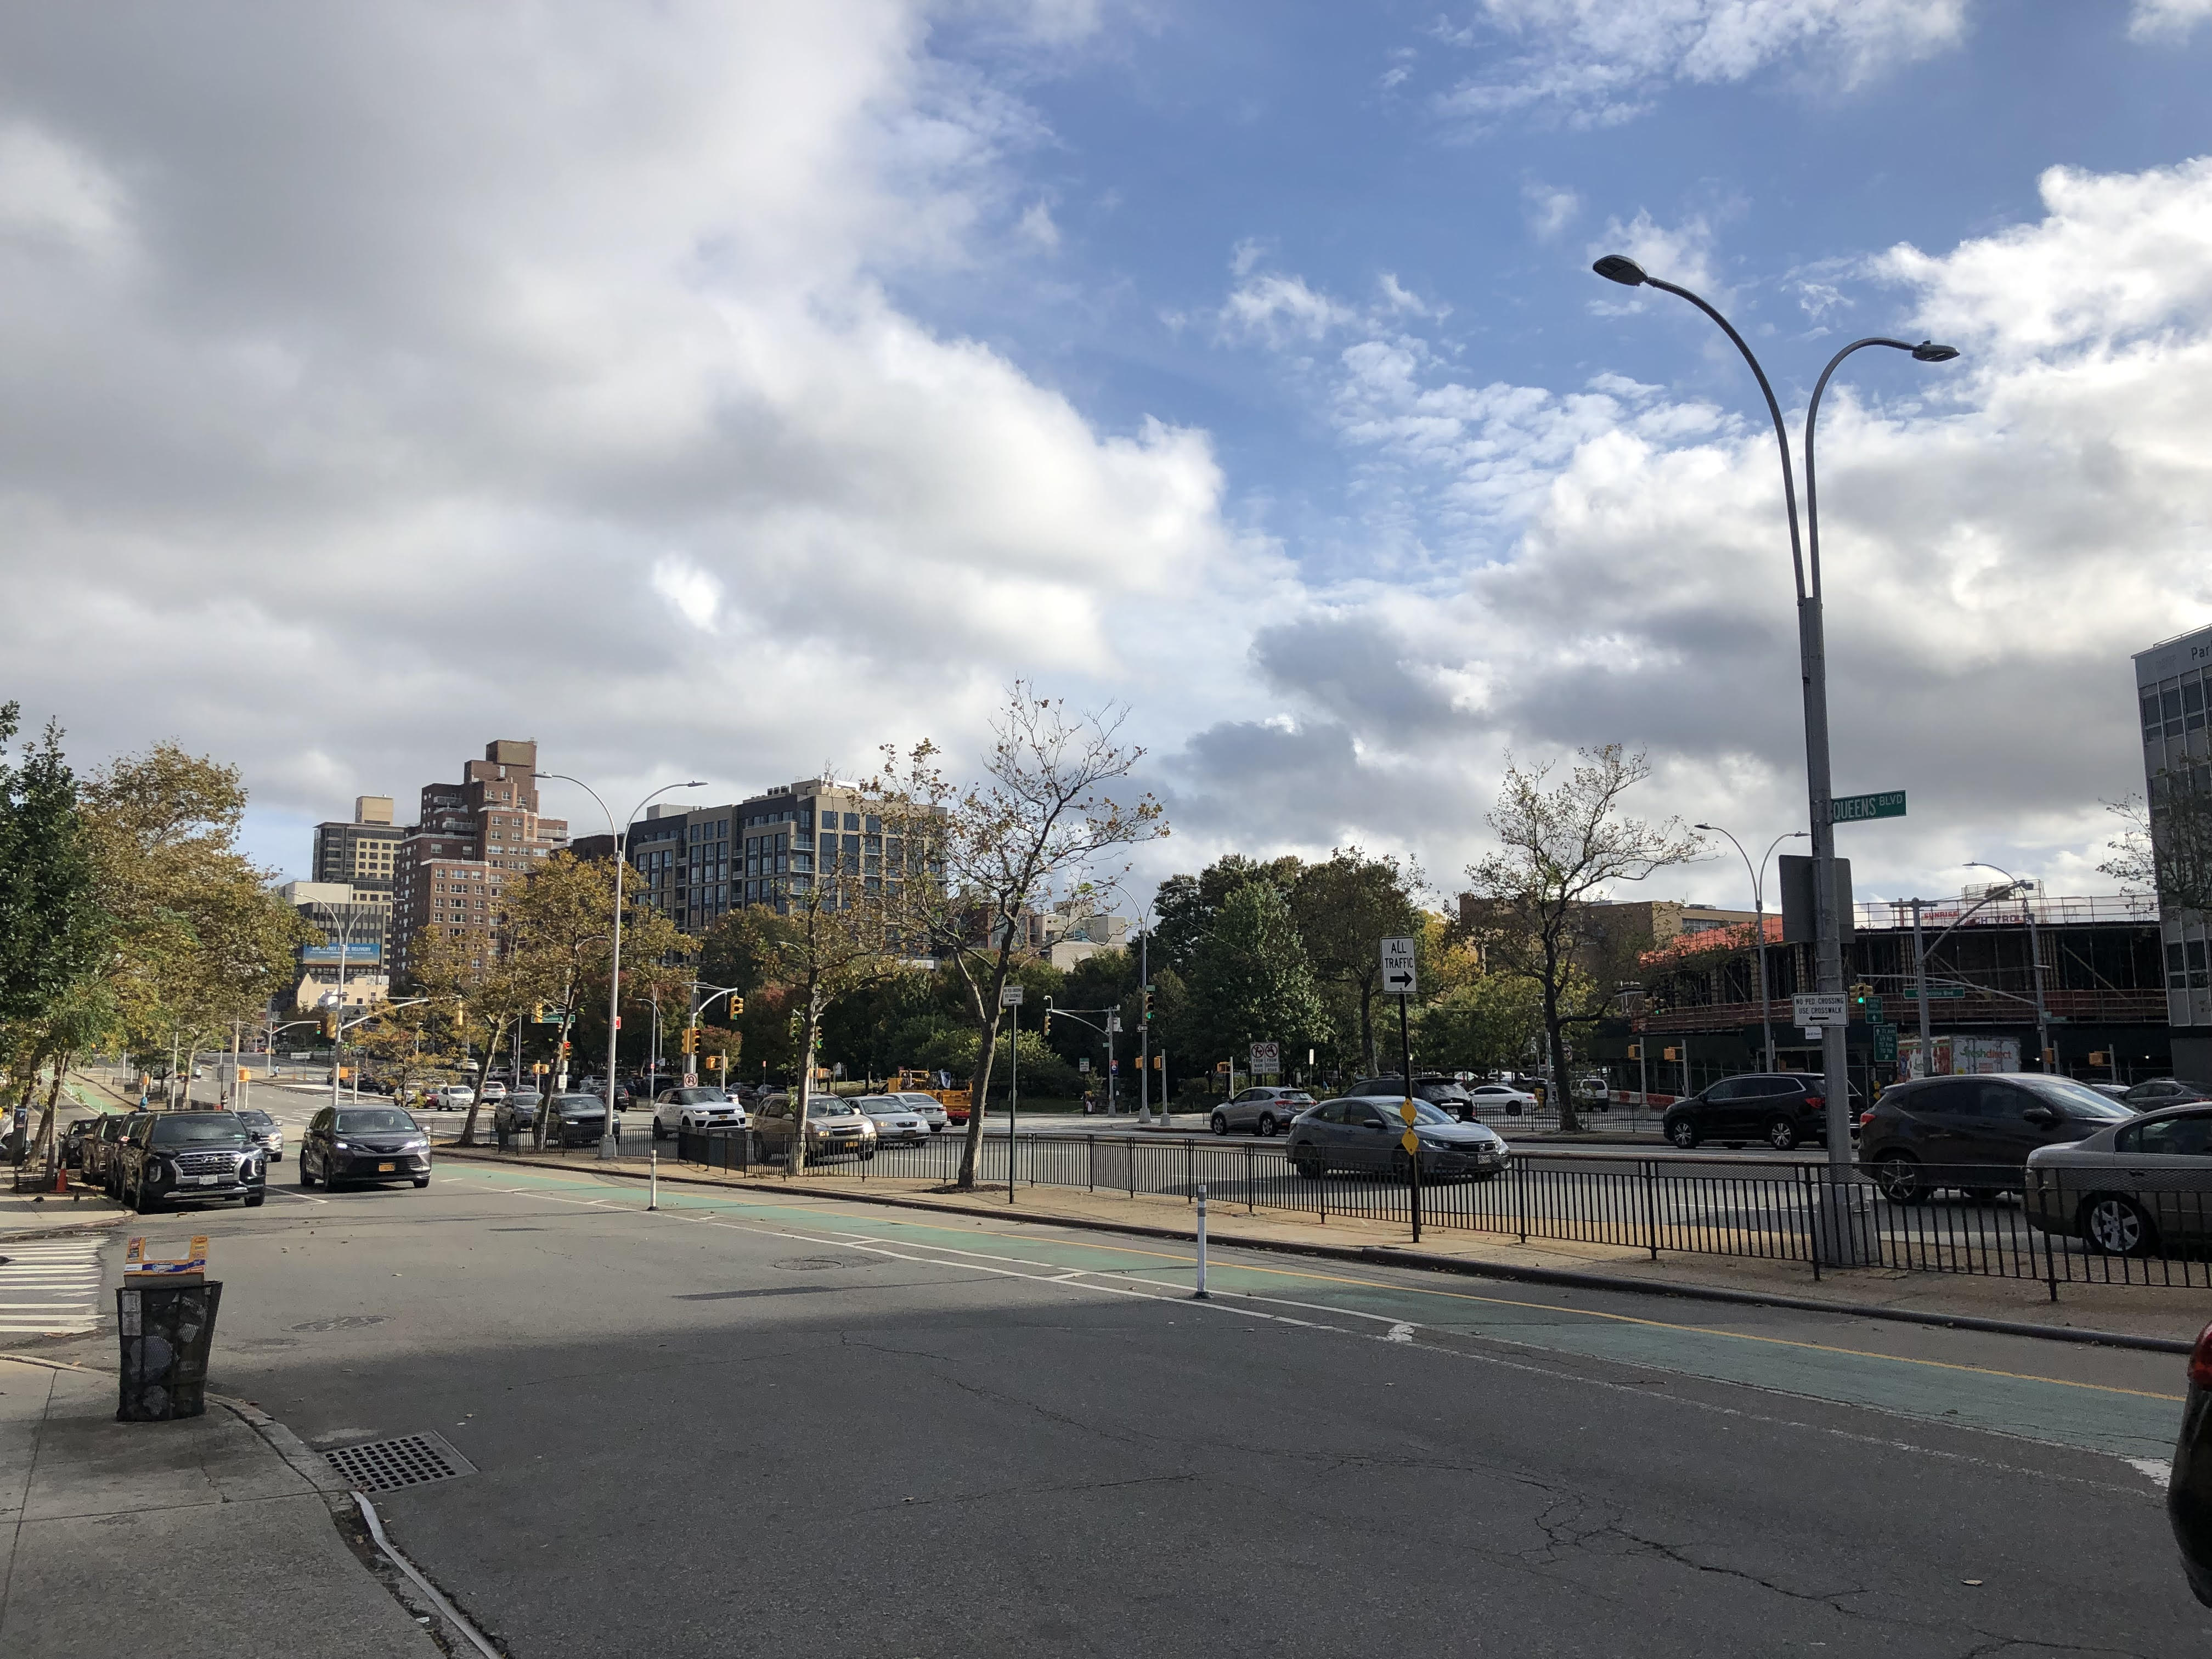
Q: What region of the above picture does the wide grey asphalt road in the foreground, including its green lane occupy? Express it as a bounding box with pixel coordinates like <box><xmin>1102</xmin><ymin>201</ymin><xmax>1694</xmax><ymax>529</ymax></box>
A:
<box><xmin>21</xmin><ymin>1161</ymin><xmax>2212</xmax><ymax>1659</ymax></box>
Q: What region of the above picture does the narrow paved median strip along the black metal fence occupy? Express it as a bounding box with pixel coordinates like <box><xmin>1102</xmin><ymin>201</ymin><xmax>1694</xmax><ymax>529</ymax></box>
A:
<box><xmin>438</xmin><ymin>1144</ymin><xmax>2212</xmax><ymax>1342</ymax></box>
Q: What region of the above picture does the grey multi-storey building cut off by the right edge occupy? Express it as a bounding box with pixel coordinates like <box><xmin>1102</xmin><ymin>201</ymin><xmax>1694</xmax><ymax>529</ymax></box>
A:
<box><xmin>2135</xmin><ymin>628</ymin><xmax>2212</xmax><ymax>1077</ymax></box>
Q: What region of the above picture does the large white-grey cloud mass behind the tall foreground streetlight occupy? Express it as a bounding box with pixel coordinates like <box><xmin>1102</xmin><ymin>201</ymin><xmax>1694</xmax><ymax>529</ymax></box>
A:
<box><xmin>1183</xmin><ymin>161</ymin><xmax>2212</xmax><ymax>898</ymax></box>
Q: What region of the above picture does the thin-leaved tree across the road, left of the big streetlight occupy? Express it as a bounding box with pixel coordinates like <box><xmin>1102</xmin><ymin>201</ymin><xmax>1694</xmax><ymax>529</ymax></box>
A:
<box><xmin>1466</xmin><ymin>743</ymin><xmax>1699</xmax><ymax>1130</ymax></box>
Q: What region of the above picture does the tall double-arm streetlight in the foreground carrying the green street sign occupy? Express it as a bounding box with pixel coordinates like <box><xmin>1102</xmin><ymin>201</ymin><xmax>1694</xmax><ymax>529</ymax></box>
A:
<box><xmin>1590</xmin><ymin>255</ymin><xmax>1957</xmax><ymax>1261</ymax></box>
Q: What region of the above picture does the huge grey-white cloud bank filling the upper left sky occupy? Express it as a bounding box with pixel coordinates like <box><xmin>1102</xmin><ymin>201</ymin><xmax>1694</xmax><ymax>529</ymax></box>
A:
<box><xmin>0</xmin><ymin>0</ymin><xmax>1278</xmax><ymax>858</ymax></box>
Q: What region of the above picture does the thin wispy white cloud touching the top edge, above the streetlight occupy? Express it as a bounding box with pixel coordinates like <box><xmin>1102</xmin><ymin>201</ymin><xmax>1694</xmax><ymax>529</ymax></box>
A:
<box><xmin>1438</xmin><ymin>0</ymin><xmax>1966</xmax><ymax>128</ymax></box>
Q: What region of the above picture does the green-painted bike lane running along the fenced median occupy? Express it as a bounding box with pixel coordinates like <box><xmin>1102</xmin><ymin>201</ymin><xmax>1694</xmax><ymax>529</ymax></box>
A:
<box><xmin>444</xmin><ymin>1164</ymin><xmax>2183</xmax><ymax>1475</ymax></box>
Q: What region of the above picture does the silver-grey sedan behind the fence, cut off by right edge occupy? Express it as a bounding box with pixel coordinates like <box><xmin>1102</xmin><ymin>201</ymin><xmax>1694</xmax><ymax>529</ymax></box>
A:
<box><xmin>2024</xmin><ymin>1104</ymin><xmax>2212</xmax><ymax>1256</ymax></box>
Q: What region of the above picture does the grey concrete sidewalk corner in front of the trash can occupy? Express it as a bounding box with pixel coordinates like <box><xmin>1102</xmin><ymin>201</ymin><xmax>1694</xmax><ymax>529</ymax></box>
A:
<box><xmin>0</xmin><ymin>1358</ymin><xmax>438</xmax><ymax>1659</ymax></box>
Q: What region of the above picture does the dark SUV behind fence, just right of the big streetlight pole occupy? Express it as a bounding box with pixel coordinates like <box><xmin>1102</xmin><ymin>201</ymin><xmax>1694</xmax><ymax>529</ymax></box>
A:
<box><xmin>1858</xmin><ymin>1070</ymin><xmax>2135</xmax><ymax>1203</ymax></box>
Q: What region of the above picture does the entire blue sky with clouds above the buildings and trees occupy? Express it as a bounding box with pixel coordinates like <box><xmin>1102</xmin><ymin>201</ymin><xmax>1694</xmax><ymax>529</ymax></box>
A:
<box><xmin>0</xmin><ymin>0</ymin><xmax>2212</xmax><ymax>905</ymax></box>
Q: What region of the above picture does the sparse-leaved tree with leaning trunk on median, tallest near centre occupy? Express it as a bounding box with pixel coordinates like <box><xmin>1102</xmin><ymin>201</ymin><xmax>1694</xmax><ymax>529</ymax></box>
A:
<box><xmin>876</xmin><ymin>681</ymin><xmax>1168</xmax><ymax>1190</ymax></box>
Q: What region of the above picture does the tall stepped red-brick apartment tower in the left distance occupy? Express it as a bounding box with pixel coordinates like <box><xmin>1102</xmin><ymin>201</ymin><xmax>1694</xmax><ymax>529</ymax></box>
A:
<box><xmin>392</xmin><ymin>739</ymin><xmax>568</xmax><ymax>978</ymax></box>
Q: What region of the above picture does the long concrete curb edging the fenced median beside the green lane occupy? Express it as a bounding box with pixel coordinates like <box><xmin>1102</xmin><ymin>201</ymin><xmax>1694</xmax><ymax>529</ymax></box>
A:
<box><xmin>440</xmin><ymin>1146</ymin><xmax>2192</xmax><ymax>1356</ymax></box>
